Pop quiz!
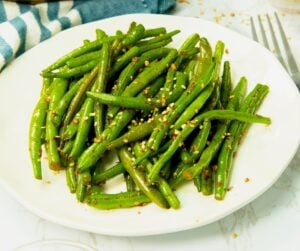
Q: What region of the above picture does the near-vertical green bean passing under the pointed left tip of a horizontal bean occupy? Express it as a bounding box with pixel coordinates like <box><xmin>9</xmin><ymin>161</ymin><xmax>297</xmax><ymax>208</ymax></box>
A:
<box><xmin>94</xmin><ymin>40</ymin><xmax>111</xmax><ymax>136</ymax></box>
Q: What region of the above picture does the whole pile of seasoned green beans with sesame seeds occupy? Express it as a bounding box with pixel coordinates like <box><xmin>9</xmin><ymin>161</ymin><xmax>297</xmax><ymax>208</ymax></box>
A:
<box><xmin>29</xmin><ymin>22</ymin><xmax>271</xmax><ymax>209</ymax></box>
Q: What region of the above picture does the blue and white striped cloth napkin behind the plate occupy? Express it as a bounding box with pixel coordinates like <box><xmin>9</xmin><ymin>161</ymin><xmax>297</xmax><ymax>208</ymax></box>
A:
<box><xmin>0</xmin><ymin>0</ymin><xmax>176</xmax><ymax>71</ymax></box>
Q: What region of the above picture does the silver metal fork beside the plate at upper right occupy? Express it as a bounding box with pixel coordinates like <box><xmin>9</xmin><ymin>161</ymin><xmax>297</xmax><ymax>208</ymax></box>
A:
<box><xmin>250</xmin><ymin>12</ymin><xmax>300</xmax><ymax>89</ymax></box>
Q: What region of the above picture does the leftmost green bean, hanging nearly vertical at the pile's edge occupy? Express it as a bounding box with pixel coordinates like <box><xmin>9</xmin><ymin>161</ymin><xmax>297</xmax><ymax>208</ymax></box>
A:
<box><xmin>29</xmin><ymin>78</ymin><xmax>51</xmax><ymax>179</ymax></box>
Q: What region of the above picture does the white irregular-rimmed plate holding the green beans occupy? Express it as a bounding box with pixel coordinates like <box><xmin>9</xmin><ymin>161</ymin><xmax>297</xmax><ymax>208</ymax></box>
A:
<box><xmin>0</xmin><ymin>14</ymin><xmax>300</xmax><ymax>236</ymax></box>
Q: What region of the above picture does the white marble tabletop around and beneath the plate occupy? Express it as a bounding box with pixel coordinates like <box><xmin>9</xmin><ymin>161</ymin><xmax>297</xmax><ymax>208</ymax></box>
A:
<box><xmin>0</xmin><ymin>0</ymin><xmax>300</xmax><ymax>251</ymax></box>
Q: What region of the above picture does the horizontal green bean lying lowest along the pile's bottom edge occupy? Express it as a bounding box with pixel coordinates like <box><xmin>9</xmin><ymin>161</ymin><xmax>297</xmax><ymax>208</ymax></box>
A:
<box><xmin>87</xmin><ymin>192</ymin><xmax>151</xmax><ymax>210</ymax></box>
